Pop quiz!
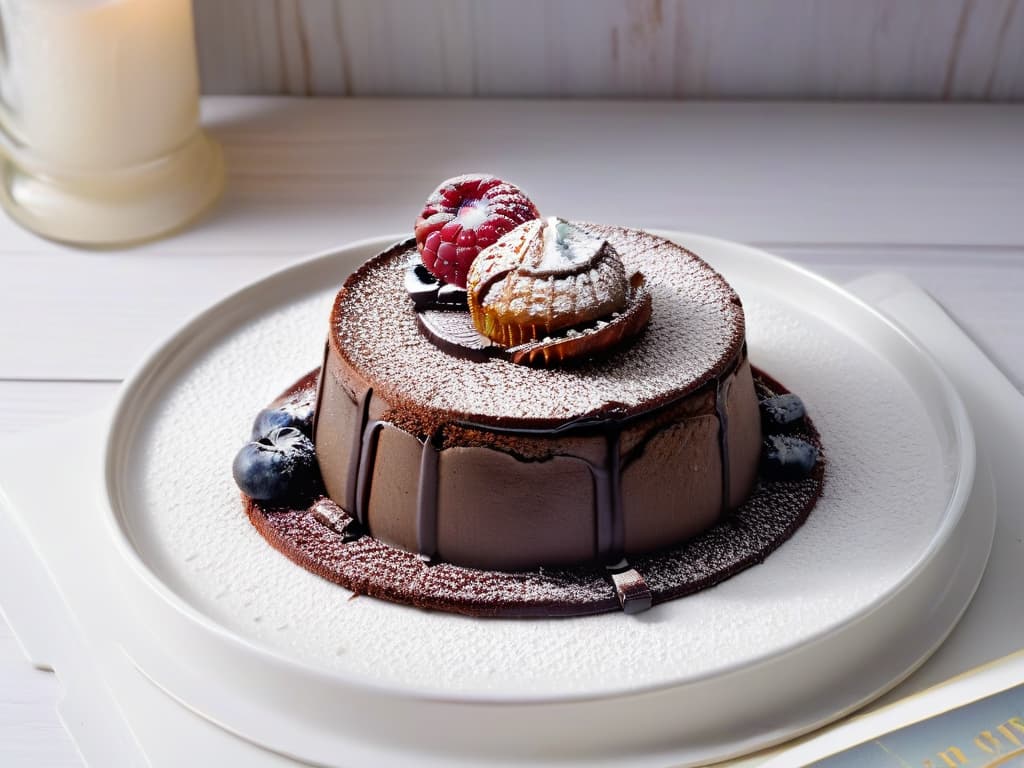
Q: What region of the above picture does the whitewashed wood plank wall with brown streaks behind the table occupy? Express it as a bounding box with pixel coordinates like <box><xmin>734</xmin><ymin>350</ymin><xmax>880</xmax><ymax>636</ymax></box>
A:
<box><xmin>196</xmin><ymin>0</ymin><xmax>1024</xmax><ymax>100</ymax></box>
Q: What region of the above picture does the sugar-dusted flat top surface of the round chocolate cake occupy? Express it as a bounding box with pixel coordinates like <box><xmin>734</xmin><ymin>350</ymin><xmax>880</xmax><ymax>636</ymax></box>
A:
<box><xmin>331</xmin><ymin>222</ymin><xmax>744</xmax><ymax>428</ymax></box>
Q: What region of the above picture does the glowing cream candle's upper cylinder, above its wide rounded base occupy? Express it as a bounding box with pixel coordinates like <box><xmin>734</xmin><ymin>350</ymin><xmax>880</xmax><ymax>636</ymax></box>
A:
<box><xmin>0</xmin><ymin>0</ymin><xmax>199</xmax><ymax>168</ymax></box>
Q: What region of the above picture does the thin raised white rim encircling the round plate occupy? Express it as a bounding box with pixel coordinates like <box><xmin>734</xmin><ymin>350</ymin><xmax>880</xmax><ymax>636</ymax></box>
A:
<box><xmin>99</xmin><ymin>229</ymin><xmax>976</xmax><ymax>706</ymax></box>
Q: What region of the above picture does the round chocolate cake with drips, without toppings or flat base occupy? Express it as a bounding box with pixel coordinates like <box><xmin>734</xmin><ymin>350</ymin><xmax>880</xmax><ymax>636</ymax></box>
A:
<box><xmin>314</xmin><ymin>223</ymin><xmax>761</xmax><ymax>570</ymax></box>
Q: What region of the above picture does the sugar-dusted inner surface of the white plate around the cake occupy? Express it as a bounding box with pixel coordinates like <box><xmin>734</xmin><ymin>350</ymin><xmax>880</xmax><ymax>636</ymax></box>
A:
<box><xmin>117</xmin><ymin>237</ymin><xmax>951</xmax><ymax>695</ymax></box>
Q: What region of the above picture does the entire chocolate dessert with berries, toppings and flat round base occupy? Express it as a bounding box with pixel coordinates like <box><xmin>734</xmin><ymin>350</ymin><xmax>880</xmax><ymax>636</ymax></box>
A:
<box><xmin>236</xmin><ymin>177</ymin><xmax>823</xmax><ymax>615</ymax></box>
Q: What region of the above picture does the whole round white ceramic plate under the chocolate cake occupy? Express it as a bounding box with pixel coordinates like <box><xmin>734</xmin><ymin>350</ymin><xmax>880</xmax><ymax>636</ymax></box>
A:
<box><xmin>104</xmin><ymin>233</ymin><xmax>992</xmax><ymax>765</ymax></box>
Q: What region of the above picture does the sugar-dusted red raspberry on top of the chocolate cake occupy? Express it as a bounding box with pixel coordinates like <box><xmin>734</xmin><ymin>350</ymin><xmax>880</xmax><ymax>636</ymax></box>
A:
<box><xmin>416</xmin><ymin>173</ymin><xmax>541</xmax><ymax>288</ymax></box>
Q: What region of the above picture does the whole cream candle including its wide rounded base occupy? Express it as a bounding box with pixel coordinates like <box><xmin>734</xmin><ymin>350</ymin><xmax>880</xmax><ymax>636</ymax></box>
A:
<box><xmin>0</xmin><ymin>0</ymin><xmax>221</xmax><ymax>244</ymax></box>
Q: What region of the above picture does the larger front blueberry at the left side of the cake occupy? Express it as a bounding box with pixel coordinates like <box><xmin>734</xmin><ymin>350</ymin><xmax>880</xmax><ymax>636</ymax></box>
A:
<box><xmin>231</xmin><ymin>427</ymin><xmax>317</xmax><ymax>502</ymax></box>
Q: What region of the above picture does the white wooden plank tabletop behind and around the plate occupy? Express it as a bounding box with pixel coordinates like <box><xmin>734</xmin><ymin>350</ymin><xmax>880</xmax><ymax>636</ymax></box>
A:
<box><xmin>0</xmin><ymin>97</ymin><xmax>1024</xmax><ymax>767</ymax></box>
